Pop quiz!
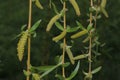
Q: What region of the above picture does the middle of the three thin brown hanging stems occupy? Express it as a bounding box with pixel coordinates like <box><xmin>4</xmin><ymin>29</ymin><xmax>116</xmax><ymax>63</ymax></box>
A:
<box><xmin>62</xmin><ymin>1</ymin><xmax>66</xmax><ymax>77</ymax></box>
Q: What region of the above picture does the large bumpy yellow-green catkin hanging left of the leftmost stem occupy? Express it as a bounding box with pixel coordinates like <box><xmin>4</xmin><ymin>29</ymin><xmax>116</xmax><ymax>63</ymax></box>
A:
<box><xmin>17</xmin><ymin>30</ymin><xmax>28</xmax><ymax>61</ymax></box>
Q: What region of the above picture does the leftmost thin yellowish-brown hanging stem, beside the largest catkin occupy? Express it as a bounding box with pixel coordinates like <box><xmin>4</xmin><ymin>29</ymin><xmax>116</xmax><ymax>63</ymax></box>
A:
<box><xmin>26</xmin><ymin>0</ymin><xmax>32</xmax><ymax>80</ymax></box>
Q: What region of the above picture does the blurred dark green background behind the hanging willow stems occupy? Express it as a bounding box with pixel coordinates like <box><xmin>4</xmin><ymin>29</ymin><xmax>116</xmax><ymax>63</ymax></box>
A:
<box><xmin>0</xmin><ymin>0</ymin><xmax>120</xmax><ymax>80</ymax></box>
